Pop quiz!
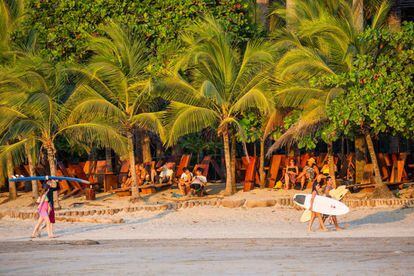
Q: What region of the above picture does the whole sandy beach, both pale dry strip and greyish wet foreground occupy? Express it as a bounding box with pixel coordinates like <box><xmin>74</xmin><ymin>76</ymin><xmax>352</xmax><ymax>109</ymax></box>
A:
<box><xmin>0</xmin><ymin>190</ymin><xmax>414</xmax><ymax>275</ymax></box>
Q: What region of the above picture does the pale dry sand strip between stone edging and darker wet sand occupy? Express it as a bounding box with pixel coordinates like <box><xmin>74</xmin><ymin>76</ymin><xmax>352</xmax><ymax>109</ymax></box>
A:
<box><xmin>0</xmin><ymin>206</ymin><xmax>414</xmax><ymax>241</ymax></box>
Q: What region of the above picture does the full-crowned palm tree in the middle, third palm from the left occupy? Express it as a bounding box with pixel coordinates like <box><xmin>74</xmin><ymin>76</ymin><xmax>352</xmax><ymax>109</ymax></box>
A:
<box><xmin>161</xmin><ymin>17</ymin><xmax>273</xmax><ymax>194</ymax></box>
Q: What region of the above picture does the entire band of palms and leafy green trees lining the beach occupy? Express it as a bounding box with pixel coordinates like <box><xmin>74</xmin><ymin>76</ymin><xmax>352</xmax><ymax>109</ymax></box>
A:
<box><xmin>0</xmin><ymin>0</ymin><xmax>414</xmax><ymax>197</ymax></box>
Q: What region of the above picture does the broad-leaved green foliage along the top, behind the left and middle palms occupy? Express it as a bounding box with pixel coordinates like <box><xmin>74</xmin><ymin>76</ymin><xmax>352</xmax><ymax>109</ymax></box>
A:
<box><xmin>17</xmin><ymin>0</ymin><xmax>254</xmax><ymax>70</ymax></box>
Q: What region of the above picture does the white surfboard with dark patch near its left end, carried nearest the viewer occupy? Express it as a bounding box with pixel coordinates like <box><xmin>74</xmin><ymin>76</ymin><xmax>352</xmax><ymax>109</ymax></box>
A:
<box><xmin>293</xmin><ymin>194</ymin><xmax>349</xmax><ymax>216</ymax></box>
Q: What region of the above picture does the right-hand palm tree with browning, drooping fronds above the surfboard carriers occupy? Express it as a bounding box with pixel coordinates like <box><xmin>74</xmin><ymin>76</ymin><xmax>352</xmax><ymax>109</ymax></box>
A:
<box><xmin>271</xmin><ymin>0</ymin><xmax>390</xmax><ymax>194</ymax></box>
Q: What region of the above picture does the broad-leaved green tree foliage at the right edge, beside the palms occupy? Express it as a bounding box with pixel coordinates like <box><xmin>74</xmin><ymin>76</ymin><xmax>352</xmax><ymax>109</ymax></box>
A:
<box><xmin>322</xmin><ymin>23</ymin><xmax>414</xmax><ymax>137</ymax></box>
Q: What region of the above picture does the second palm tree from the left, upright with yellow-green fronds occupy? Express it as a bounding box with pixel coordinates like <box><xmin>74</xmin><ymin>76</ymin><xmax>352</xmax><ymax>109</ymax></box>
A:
<box><xmin>69</xmin><ymin>22</ymin><xmax>164</xmax><ymax>199</ymax></box>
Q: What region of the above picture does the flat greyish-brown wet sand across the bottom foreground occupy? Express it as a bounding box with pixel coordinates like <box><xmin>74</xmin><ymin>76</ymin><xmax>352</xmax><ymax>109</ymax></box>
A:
<box><xmin>0</xmin><ymin>237</ymin><xmax>414</xmax><ymax>275</ymax></box>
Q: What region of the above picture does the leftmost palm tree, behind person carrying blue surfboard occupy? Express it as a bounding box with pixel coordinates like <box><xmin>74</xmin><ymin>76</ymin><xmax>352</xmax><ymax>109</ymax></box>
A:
<box><xmin>0</xmin><ymin>56</ymin><xmax>125</xmax><ymax>205</ymax></box>
